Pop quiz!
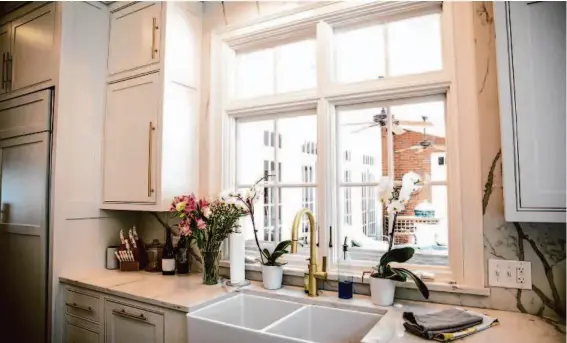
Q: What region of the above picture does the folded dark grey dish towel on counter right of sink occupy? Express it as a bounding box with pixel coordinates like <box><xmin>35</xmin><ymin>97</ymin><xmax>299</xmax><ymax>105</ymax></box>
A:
<box><xmin>403</xmin><ymin>308</ymin><xmax>498</xmax><ymax>342</ymax></box>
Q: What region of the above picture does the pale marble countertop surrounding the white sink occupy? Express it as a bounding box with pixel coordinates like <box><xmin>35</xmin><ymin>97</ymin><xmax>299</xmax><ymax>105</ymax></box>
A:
<box><xmin>59</xmin><ymin>270</ymin><xmax>565</xmax><ymax>343</ymax></box>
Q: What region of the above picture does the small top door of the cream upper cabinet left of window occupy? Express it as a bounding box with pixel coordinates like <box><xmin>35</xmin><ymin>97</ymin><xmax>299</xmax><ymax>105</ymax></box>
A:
<box><xmin>108</xmin><ymin>2</ymin><xmax>161</xmax><ymax>75</ymax></box>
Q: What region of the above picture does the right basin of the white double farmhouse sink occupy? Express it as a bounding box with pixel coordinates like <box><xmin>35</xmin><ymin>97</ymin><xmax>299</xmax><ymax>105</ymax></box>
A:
<box><xmin>266</xmin><ymin>306</ymin><xmax>380</xmax><ymax>343</ymax></box>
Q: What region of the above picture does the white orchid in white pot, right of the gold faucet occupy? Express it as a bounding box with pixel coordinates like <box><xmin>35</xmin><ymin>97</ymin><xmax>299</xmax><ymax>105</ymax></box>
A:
<box><xmin>362</xmin><ymin>172</ymin><xmax>429</xmax><ymax>306</ymax></box>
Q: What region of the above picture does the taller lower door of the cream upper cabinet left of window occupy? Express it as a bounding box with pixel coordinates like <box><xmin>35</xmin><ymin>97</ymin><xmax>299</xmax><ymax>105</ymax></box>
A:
<box><xmin>103</xmin><ymin>73</ymin><xmax>160</xmax><ymax>204</ymax></box>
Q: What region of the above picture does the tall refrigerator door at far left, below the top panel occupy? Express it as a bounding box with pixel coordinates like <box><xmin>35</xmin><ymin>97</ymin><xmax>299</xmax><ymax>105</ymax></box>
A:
<box><xmin>0</xmin><ymin>132</ymin><xmax>50</xmax><ymax>342</ymax></box>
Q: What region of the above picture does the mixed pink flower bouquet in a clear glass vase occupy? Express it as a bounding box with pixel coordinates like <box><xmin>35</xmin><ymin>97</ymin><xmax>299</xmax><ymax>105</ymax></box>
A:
<box><xmin>170</xmin><ymin>194</ymin><xmax>246</xmax><ymax>285</ymax></box>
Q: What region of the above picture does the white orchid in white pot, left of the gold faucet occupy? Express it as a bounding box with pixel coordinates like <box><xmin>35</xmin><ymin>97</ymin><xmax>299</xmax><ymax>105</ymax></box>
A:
<box><xmin>228</xmin><ymin>175</ymin><xmax>291</xmax><ymax>289</ymax></box>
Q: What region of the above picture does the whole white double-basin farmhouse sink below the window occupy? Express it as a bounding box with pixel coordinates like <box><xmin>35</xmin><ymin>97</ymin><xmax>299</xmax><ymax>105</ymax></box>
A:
<box><xmin>187</xmin><ymin>294</ymin><xmax>382</xmax><ymax>343</ymax></box>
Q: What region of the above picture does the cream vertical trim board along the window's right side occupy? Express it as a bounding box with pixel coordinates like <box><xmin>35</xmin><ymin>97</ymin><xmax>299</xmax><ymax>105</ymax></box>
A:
<box><xmin>444</xmin><ymin>2</ymin><xmax>485</xmax><ymax>287</ymax></box>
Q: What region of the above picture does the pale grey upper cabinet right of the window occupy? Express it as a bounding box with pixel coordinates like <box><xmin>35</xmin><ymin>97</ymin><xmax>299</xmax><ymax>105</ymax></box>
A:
<box><xmin>494</xmin><ymin>1</ymin><xmax>566</xmax><ymax>222</ymax></box>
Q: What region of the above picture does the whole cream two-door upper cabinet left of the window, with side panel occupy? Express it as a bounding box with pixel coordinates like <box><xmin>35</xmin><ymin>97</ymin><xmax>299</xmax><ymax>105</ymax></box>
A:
<box><xmin>101</xmin><ymin>2</ymin><xmax>202</xmax><ymax>211</ymax></box>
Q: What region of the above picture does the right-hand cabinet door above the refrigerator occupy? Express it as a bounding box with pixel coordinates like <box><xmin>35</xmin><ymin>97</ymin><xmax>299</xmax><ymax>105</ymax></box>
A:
<box><xmin>9</xmin><ymin>3</ymin><xmax>55</xmax><ymax>92</ymax></box>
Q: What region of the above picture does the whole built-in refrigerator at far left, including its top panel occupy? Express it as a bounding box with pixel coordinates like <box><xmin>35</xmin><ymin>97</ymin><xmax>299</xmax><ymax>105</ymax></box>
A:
<box><xmin>0</xmin><ymin>90</ymin><xmax>53</xmax><ymax>343</ymax></box>
